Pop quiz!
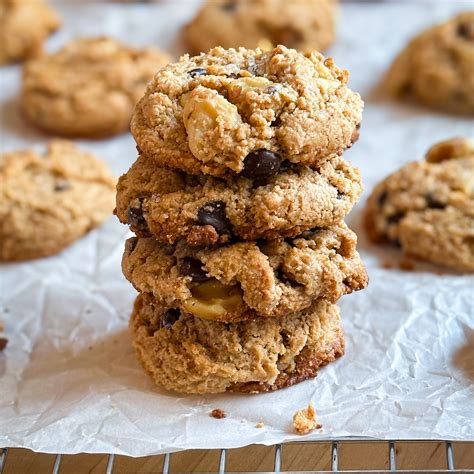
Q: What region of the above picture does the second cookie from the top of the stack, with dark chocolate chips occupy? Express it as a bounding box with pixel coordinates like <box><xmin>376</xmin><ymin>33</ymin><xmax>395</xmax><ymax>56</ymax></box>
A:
<box><xmin>116</xmin><ymin>155</ymin><xmax>362</xmax><ymax>246</ymax></box>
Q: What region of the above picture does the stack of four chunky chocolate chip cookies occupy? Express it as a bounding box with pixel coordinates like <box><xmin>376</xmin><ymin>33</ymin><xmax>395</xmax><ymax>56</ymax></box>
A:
<box><xmin>116</xmin><ymin>46</ymin><xmax>367</xmax><ymax>393</ymax></box>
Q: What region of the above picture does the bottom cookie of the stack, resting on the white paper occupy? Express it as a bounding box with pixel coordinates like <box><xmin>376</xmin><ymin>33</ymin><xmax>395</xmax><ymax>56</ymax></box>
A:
<box><xmin>130</xmin><ymin>295</ymin><xmax>344</xmax><ymax>393</ymax></box>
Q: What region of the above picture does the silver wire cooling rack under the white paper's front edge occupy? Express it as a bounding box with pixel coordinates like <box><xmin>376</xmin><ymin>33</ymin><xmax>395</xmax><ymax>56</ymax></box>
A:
<box><xmin>0</xmin><ymin>438</ymin><xmax>474</xmax><ymax>474</ymax></box>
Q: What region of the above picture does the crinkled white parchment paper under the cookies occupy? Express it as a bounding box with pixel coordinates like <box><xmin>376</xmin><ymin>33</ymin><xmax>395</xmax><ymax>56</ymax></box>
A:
<box><xmin>0</xmin><ymin>0</ymin><xmax>474</xmax><ymax>456</ymax></box>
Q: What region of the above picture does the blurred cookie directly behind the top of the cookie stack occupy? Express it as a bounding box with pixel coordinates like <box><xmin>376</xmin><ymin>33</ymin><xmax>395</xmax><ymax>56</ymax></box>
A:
<box><xmin>184</xmin><ymin>0</ymin><xmax>336</xmax><ymax>54</ymax></box>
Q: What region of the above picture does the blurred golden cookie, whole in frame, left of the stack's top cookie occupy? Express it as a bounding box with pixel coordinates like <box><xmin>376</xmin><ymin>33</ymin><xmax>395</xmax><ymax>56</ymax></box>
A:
<box><xmin>22</xmin><ymin>37</ymin><xmax>169</xmax><ymax>137</ymax></box>
